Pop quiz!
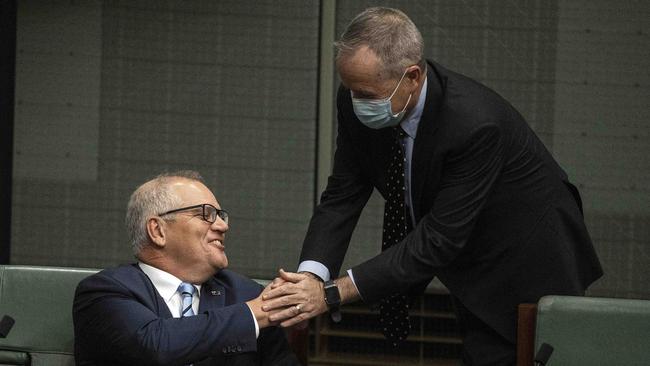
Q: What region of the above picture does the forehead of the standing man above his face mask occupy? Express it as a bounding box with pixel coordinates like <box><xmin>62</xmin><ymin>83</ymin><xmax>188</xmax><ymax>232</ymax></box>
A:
<box><xmin>336</xmin><ymin>46</ymin><xmax>390</xmax><ymax>94</ymax></box>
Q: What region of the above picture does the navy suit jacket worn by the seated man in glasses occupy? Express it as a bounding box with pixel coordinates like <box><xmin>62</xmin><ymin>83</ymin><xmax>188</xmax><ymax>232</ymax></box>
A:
<box><xmin>73</xmin><ymin>264</ymin><xmax>298</xmax><ymax>366</ymax></box>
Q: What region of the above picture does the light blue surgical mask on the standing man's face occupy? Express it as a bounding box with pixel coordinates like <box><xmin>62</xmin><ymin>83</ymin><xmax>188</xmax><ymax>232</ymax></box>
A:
<box><xmin>352</xmin><ymin>70</ymin><xmax>412</xmax><ymax>129</ymax></box>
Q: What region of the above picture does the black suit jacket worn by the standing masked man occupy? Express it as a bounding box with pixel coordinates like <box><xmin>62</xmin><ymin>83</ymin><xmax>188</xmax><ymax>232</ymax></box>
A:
<box><xmin>301</xmin><ymin>62</ymin><xmax>602</xmax><ymax>342</ymax></box>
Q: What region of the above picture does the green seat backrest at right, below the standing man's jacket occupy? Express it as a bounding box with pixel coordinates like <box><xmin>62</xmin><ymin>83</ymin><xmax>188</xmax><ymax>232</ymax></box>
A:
<box><xmin>535</xmin><ymin>296</ymin><xmax>650</xmax><ymax>366</ymax></box>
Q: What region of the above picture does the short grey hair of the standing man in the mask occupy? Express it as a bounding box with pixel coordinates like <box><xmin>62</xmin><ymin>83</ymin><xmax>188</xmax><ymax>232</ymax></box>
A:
<box><xmin>334</xmin><ymin>7</ymin><xmax>426</xmax><ymax>77</ymax></box>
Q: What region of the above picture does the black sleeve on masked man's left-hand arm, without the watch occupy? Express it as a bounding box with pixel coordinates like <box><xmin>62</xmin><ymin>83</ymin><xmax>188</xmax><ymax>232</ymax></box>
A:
<box><xmin>300</xmin><ymin>89</ymin><xmax>373</xmax><ymax>277</ymax></box>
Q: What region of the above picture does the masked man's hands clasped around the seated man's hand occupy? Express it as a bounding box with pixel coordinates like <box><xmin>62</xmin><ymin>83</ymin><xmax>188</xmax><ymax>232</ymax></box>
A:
<box><xmin>262</xmin><ymin>269</ymin><xmax>327</xmax><ymax>327</ymax></box>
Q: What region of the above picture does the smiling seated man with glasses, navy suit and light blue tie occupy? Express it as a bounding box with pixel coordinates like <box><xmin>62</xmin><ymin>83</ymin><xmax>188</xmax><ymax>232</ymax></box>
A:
<box><xmin>73</xmin><ymin>171</ymin><xmax>298</xmax><ymax>365</ymax></box>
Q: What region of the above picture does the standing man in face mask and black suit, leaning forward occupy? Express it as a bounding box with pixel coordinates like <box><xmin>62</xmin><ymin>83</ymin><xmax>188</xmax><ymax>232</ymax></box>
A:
<box><xmin>263</xmin><ymin>8</ymin><xmax>602</xmax><ymax>365</ymax></box>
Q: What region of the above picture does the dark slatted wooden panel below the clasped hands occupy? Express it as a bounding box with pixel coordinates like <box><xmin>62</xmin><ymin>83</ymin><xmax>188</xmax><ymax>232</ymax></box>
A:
<box><xmin>308</xmin><ymin>293</ymin><xmax>462</xmax><ymax>366</ymax></box>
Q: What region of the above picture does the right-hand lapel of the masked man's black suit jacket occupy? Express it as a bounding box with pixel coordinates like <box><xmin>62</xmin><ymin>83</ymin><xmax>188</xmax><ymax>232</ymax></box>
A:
<box><xmin>411</xmin><ymin>63</ymin><xmax>444</xmax><ymax>220</ymax></box>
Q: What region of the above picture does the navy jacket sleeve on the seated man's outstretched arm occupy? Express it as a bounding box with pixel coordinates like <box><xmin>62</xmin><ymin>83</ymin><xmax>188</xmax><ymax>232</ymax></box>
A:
<box><xmin>73</xmin><ymin>272</ymin><xmax>257</xmax><ymax>365</ymax></box>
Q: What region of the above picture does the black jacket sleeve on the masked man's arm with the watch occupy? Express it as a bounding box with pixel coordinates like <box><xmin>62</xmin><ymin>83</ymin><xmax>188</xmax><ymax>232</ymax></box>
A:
<box><xmin>352</xmin><ymin>124</ymin><xmax>504</xmax><ymax>302</ymax></box>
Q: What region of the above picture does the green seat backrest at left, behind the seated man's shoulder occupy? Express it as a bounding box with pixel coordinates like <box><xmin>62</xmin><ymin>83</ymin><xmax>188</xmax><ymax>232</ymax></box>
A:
<box><xmin>0</xmin><ymin>265</ymin><xmax>98</xmax><ymax>366</ymax></box>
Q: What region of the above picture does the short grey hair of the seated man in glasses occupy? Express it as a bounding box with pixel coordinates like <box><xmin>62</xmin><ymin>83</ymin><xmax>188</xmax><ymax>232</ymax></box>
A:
<box><xmin>125</xmin><ymin>170</ymin><xmax>203</xmax><ymax>255</ymax></box>
